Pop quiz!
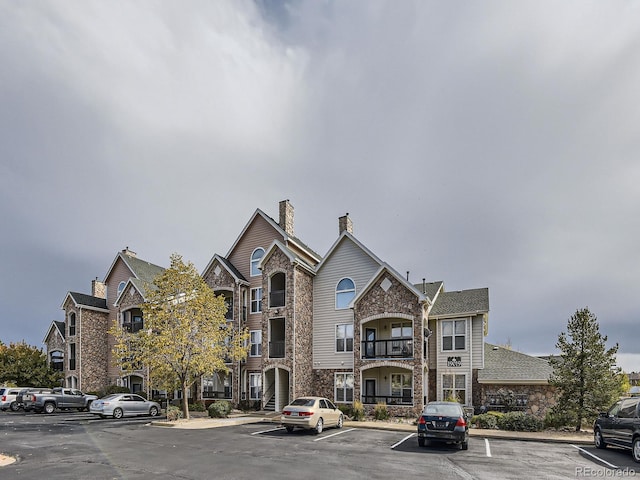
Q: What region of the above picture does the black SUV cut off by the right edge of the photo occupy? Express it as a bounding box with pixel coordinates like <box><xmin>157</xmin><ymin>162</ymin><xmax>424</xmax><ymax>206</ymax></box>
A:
<box><xmin>593</xmin><ymin>397</ymin><xmax>640</xmax><ymax>463</ymax></box>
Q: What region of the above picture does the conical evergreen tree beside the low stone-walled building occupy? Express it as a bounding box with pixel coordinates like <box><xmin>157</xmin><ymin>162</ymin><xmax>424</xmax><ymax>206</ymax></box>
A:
<box><xmin>550</xmin><ymin>308</ymin><xmax>622</xmax><ymax>431</ymax></box>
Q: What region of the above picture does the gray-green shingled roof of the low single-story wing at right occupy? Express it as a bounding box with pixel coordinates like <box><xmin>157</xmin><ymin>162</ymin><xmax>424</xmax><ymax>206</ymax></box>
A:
<box><xmin>478</xmin><ymin>343</ymin><xmax>553</xmax><ymax>384</ymax></box>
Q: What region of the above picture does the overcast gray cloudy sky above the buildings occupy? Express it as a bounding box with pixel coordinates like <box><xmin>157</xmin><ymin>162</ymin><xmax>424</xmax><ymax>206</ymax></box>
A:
<box><xmin>0</xmin><ymin>0</ymin><xmax>640</xmax><ymax>371</ymax></box>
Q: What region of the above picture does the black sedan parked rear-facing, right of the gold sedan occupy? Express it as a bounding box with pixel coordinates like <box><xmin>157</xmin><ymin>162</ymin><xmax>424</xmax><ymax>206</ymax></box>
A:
<box><xmin>418</xmin><ymin>402</ymin><xmax>469</xmax><ymax>450</ymax></box>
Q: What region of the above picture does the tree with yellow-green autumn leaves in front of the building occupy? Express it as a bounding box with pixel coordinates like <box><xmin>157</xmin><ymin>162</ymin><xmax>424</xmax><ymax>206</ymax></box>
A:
<box><xmin>110</xmin><ymin>254</ymin><xmax>248</xmax><ymax>419</ymax></box>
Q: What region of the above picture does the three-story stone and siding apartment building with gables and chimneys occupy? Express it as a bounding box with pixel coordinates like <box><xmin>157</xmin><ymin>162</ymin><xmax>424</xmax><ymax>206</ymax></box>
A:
<box><xmin>45</xmin><ymin>200</ymin><xmax>489</xmax><ymax>415</ymax></box>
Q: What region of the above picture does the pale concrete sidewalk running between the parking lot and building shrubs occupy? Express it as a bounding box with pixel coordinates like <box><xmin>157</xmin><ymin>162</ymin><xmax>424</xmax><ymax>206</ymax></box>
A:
<box><xmin>151</xmin><ymin>412</ymin><xmax>593</xmax><ymax>445</ymax></box>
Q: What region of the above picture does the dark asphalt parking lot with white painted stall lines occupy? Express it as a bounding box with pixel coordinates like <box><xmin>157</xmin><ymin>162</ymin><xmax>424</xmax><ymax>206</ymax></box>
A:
<box><xmin>0</xmin><ymin>412</ymin><xmax>640</xmax><ymax>480</ymax></box>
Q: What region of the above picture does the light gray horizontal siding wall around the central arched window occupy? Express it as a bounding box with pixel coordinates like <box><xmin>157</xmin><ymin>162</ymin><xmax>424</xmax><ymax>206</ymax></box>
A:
<box><xmin>313</xmin><ymin>237</ymin><xmax>380</xmax><ymax>369</ymax></box>
